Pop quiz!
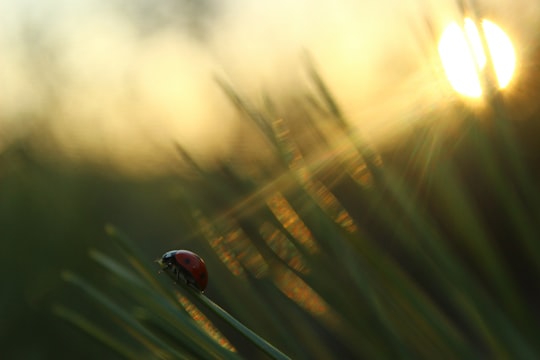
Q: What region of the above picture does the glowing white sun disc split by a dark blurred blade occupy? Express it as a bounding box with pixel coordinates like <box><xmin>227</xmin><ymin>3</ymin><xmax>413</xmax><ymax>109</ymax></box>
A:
<box><xmin>439</xmin><ymin>18</ymin><xmax>516</xmax><ymax>97</ymax></box>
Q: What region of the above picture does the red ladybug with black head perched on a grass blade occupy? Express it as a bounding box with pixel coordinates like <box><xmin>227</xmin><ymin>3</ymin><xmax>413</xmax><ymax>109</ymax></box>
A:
<box><xmin>160</xmin><ymin>250</ymin><xmax>208</xmax><ymax>291</ymax></box>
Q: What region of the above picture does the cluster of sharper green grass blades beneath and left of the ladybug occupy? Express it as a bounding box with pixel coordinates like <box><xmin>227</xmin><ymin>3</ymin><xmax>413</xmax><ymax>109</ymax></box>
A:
<box><xmin>55</xmin><ymin>226</ymin><xmax>288</xmax><ymax>359</ymax></box>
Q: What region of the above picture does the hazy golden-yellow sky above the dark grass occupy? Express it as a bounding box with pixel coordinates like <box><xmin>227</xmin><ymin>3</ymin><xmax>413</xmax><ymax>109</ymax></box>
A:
<box><xmin>0</xmin><ymin>0</ymin><xmax>540</xmax><ymax>175</ymax></box>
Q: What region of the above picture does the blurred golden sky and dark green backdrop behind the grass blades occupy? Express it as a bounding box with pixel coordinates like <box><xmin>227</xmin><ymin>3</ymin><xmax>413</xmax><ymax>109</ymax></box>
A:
<box><xmin>0</xmin><ymin>0</ymin><xmax>540</xmax><ymax>359</ymax></box>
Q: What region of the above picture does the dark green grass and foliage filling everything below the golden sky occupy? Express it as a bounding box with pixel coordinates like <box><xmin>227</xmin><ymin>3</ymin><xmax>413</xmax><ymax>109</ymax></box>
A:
<box><xmin>0</xmin><ymin>51</ymin><xmax>540</xmax><ymax>359</ymax></box>
